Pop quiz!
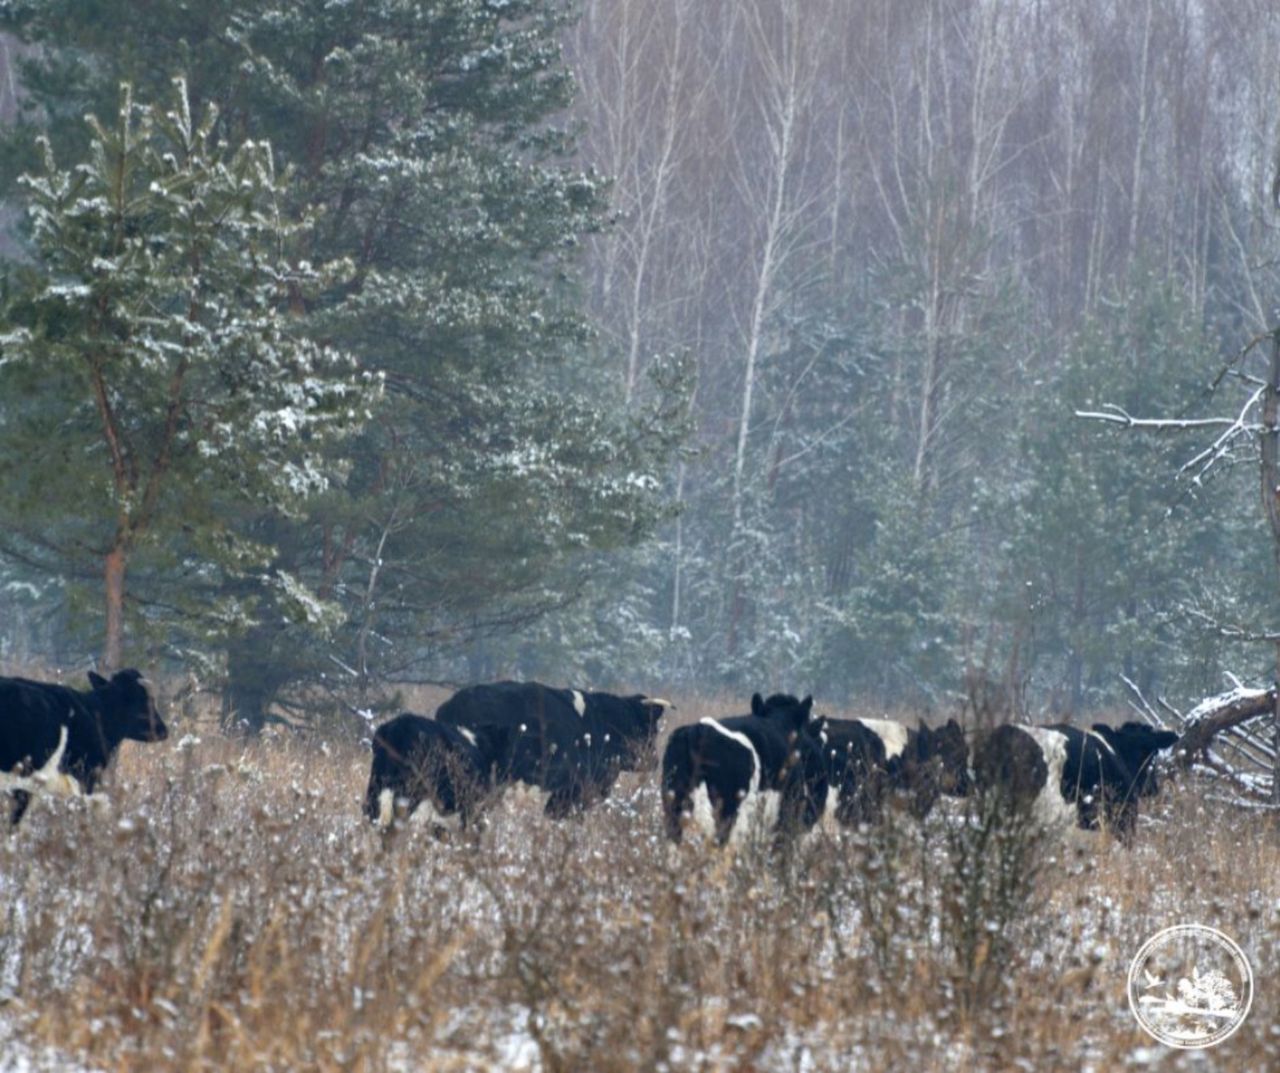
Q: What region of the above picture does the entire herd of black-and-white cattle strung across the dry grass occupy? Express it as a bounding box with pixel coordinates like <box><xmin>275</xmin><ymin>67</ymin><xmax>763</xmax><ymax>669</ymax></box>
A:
<box><xmin>0</xmin><ymin>670</ymin><xmax>1178</xmax><ymax>845</ymax></box>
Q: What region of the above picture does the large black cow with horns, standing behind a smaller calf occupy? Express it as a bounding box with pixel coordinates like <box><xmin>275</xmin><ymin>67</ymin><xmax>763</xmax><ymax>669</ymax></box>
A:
<box><xmin>435</xmin><ymin>681</ymin><xmax>672</xmax><ymax>817</ymax></box>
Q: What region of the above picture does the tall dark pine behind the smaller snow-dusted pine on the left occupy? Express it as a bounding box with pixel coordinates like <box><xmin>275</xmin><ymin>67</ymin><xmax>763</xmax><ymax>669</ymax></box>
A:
<box><xmin>9</xmin><ymin>0</ymin><xmax>682</xmax><ymax>723</ymax></box>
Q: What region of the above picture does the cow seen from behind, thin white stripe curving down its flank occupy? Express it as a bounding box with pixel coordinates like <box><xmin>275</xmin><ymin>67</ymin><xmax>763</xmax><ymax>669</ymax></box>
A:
<box><xmin>662</xmin><ymin>693</ymin><xmax>827</xmax><ymax>845</ymax></box>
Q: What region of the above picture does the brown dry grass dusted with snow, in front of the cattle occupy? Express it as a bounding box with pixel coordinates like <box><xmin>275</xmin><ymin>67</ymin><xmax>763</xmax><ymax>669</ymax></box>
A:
<box><xmin>0</xmin><ymin>699</ymin><xmax>1280</xmax><ymax>1073</ymax></box>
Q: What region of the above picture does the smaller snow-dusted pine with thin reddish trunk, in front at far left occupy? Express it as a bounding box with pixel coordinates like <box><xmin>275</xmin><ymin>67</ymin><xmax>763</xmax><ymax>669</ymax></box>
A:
<box><xmin>0</xmin><ymin>81</ymin><xmax>379</xmax><ymax>667</ymax></box>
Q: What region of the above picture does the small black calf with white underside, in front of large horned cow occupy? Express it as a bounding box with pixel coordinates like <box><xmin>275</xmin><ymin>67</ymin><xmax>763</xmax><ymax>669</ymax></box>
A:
<box><xmin>365</xmin><ymin>712</ymin><xmax>509</xmax><ymax>834</ymax></box>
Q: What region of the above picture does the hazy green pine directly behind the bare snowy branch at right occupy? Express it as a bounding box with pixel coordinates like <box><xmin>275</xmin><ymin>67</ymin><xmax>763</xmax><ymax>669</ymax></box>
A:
<box><xmin>1007</xmin><ymin>274</ymin><xmax>1254</xmax><ymax>711</ymax></box>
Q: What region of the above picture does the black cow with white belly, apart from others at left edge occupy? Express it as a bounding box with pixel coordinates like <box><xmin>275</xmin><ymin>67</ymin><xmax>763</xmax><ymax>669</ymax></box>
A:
<box><xmin>0</xmin><ymin>670</ymin><xmax>169</xmax><ymax>826</ymax></box>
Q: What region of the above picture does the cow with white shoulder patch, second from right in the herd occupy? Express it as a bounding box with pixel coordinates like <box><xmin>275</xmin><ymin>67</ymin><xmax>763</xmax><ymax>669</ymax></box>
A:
<box><xmin>808</xmin><ymin>716</ymin><xmax>969</xmax><ymax>826</ymax></box>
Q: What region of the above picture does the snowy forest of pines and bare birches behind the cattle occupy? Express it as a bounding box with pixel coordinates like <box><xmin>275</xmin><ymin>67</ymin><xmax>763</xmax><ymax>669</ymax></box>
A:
<box><xmin>0</xmin><ymin>0</ymin><xmax>1280</xmax><ymax>726</ymax></box>
